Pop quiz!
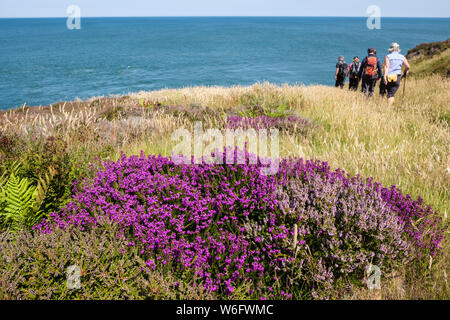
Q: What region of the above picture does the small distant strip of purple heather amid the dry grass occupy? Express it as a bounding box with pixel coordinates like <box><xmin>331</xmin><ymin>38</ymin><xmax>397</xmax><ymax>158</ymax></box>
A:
<box><xmin>226</xmin><ymin>115</ymin><xmax>311</xmax><ymax>132</ymax></box>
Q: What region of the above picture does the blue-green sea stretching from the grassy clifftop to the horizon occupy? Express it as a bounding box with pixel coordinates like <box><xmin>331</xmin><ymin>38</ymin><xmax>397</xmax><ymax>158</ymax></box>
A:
<box><xmin>0</xmin><ymin>17</ymin><xmax>450</xmax><ymax>109</ymax></box>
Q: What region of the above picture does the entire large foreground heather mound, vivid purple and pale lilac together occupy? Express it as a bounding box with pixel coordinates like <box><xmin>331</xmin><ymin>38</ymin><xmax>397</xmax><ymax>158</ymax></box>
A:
<box><xmin>36</xmin><ymin>149</ymin><xmax>443</xmax><ymax>299</ymax></box>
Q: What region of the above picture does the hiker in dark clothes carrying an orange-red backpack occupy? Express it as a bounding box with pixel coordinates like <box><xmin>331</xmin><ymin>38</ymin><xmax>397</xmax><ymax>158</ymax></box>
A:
<box><xmin>358</xmin><ymin>48</ymin><xmax>381</xmax><ymax>97</ymax></box>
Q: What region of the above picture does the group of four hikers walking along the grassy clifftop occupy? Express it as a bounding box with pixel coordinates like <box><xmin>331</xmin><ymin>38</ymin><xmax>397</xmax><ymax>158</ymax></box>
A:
<box><xmin>334</xmin><ymin>42</ymin><xmax>410</xmax><ymax>106</ymax></box>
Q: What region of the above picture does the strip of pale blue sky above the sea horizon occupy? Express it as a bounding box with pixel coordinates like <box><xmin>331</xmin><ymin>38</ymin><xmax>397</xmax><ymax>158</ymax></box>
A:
<box><xmin>0</xmin><ymin>0</ymin><xmax>450</xmax><ymax>18</ymax></box>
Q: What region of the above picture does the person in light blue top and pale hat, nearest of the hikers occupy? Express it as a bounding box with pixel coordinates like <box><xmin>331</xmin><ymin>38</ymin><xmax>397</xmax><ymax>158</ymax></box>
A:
<box><xmin>383</xmin><ymin>42</ymin><xmax>410</xmax><ymax>107</ymax></box>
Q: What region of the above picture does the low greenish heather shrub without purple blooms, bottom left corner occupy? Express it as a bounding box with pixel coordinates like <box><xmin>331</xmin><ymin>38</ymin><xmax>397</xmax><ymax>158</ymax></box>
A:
<box><xmin>0</xmin><ymin>221</ymin><xmax>213</xmax><ymax>300</ymax></box>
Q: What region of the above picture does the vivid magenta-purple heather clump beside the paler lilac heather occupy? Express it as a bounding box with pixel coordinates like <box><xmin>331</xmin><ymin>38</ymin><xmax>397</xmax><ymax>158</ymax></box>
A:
<box><xmin>40</xmin><ymin>149</ymin><xmax>288</xmax><ymax>292</ymax></box>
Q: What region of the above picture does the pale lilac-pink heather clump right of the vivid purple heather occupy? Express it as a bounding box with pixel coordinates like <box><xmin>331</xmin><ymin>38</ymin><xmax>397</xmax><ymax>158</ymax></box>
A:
<box><xmin>278</xmin><ymin>162</ymin><xmax>412</xmax><ymax>297</ymax></box>
